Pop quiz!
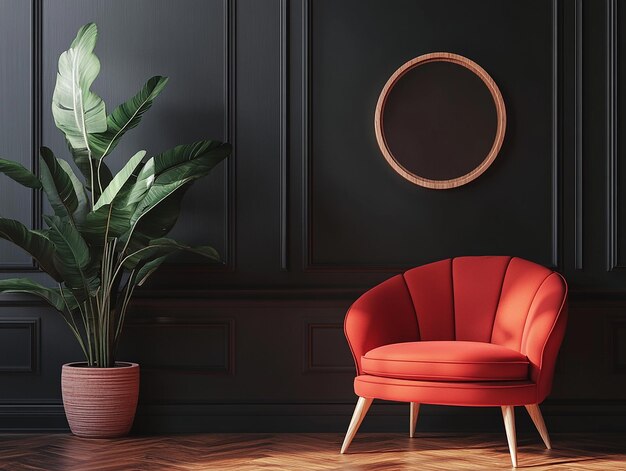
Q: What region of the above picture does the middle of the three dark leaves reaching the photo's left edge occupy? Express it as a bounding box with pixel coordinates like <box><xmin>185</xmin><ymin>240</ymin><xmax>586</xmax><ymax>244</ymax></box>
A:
<box><xmin>0</xmin><ymin>218</ymin><xmax>62</xmax><ymax>281</ymax></box>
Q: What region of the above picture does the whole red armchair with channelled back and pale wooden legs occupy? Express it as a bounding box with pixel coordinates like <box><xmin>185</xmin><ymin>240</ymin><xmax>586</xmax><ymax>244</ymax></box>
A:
<box><xmin>341</xmin><ymin>256</ymin><xmax>567</xmax><ymax>466</ymax></box>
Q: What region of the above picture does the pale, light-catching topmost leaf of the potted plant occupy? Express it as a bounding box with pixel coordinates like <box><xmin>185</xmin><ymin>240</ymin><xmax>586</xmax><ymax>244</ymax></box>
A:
<box><xmin>52</xmin><ymin>23</ymin><xmax>107</xmax><ymax>157</ymax></box>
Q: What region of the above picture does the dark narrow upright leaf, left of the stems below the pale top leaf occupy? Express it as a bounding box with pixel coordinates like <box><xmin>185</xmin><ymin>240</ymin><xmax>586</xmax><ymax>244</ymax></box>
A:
<box><xmin>39</xmin><ymin>147</ymin><xmax>78</xmax><ymax>217</ymax></box>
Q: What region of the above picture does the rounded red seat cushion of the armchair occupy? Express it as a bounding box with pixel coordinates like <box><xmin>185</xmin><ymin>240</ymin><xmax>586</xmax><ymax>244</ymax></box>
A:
<box><xmin>361</xmin><ymin>340</ymin><xmax>529</xmax><ymax>381</ymax></box>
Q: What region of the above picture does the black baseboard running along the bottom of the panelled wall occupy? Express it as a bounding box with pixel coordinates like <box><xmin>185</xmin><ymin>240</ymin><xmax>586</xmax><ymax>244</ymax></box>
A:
<box><xmin>0</xmin><ymin>402</ymin><xmax>626</xmax><ymax>434</ymax></box>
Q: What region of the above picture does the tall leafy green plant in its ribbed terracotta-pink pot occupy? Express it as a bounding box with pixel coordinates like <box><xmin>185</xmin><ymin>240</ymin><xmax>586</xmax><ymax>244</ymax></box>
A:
<box><xmin>0</xmin><ymin>23</ymin><xmax>231</xmax><ymax>437</ymax></box>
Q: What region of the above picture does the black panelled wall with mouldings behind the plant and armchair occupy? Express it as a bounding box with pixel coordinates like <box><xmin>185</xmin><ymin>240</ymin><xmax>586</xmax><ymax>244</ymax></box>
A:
<box><xmin>0</xmin><ymin>0</ymin><xmax>626</xmax><ymax>431</ymax></box>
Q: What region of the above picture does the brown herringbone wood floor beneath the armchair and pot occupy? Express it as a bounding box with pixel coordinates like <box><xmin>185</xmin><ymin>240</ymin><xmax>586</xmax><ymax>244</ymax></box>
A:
<box><xmin>0</xmin><ymin>433</ymin><xmax>626</xmax><ymax>471</ymax></box>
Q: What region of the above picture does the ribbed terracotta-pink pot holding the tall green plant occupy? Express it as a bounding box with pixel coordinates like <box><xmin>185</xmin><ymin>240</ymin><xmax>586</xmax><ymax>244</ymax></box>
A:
<box><xmin>61</xmin><ymin>362</ymin><xmax>139</xmax><ymax>438</ymax></box>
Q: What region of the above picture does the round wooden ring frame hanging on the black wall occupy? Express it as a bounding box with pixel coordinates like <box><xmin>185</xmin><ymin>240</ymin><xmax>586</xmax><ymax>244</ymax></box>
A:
<box><xmin>374</xmin><ymin>52</ymin><xmax>506</xmax><ymax>190</ymax></box>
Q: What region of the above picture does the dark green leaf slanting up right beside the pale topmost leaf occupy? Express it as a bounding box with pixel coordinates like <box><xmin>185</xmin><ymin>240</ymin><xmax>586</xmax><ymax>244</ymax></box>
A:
<box><xmin>89</xmin><ymin>76</ymin><xmax>168</xmax><ymax>158</ymax></box>
